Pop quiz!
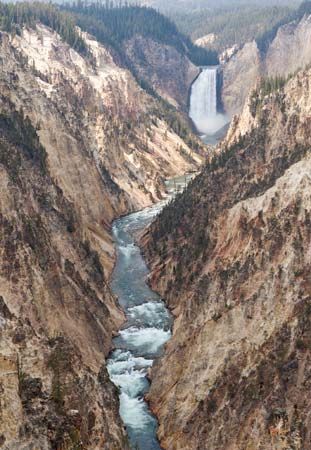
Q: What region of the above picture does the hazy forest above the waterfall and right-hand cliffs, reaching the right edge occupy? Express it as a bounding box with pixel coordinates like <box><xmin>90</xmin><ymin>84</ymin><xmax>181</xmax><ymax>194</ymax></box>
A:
<box><xmin>163</xmin><ymin>0</ymin><xmax>311</xmax><ymax>53</ymax></box>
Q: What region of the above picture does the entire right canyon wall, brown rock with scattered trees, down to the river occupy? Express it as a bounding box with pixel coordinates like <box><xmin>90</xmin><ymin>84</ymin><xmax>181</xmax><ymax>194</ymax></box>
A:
<box><xmin>142</xmin><ymin>65</ymin><xmax>311</xmax><ymax>450</ymax></box>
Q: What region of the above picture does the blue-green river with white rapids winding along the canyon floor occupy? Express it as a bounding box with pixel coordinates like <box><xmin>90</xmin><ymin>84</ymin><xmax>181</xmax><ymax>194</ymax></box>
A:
<box><xmin>107</xmin><ymin>175</ymin><xmax>192</xmax><ymax>450</ymax></box>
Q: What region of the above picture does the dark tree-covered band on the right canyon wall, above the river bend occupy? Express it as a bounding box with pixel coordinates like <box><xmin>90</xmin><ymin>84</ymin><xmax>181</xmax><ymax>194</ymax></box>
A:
<box><xmin>147</xmin><ymin>81</ymin><xmax>310</xmax><ymax>298</ymax></box>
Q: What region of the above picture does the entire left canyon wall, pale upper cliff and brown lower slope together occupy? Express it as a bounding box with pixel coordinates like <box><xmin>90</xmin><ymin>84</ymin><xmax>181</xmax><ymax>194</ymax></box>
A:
<box><xmin>0</xmin><ymin>24</ymin><xmax>202</xmax><ymax>450</ymax></box>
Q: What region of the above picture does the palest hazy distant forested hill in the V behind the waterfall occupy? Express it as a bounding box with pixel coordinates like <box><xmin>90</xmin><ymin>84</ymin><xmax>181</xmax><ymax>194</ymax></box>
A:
<box><xmin>128</xmin><ymin>0</ymin><xmax>301</xmax><ymax>51</ymax></box>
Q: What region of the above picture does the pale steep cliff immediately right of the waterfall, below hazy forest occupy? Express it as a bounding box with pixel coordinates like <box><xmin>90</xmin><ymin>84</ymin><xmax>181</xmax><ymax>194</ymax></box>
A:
<box><xmin>222</xmin><ymin>16</ymin><xmax>311</xmax><ymax>116</ymax></box>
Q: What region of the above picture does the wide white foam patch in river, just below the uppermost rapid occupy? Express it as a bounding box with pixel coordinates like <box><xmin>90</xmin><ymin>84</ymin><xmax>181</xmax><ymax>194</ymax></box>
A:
<box><xmin>120</xmin><ymin>327</ymin><xmax>171</xmax><ymax>354</ymax></box>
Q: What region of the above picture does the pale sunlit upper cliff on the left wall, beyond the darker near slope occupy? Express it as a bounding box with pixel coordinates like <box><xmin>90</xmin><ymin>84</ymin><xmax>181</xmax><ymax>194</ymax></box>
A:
<box><xmin>1</xmin><ymin>25</ymin><xmax>205</xmax><ymax>270</ymax></box>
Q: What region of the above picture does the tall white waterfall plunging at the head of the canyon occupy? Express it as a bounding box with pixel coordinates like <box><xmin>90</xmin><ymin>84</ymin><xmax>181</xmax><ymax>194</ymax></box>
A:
<box><xmin>189</xmin><ymin>66</ymin><xmax>227</xmax><ymax>135</ymax></box>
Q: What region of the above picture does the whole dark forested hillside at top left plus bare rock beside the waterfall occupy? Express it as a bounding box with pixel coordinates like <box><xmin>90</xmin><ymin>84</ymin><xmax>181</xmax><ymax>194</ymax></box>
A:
<box><xmin>0</xmin><ymin>1</ymin><xmax>218</xmax><ymax>111</ymax></box>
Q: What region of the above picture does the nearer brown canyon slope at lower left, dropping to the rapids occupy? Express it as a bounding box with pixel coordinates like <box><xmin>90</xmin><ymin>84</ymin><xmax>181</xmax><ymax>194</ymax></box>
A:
<box><xmin>0</xmin><ymin>103</ymin><xmax>127</xmax><ymax>450</ymax></box>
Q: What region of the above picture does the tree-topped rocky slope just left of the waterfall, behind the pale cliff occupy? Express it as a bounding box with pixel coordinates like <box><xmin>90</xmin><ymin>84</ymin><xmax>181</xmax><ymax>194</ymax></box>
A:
<box><xmin>63</xmin><ymin>2</ymin><xmax>218</xmax><ymax>113</ymax></box>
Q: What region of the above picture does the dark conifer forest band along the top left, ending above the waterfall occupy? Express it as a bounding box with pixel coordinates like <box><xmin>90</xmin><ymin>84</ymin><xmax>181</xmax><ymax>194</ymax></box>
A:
<box><xmin>0</xmin><ymin>1</ymin><xmax>217</xmax><ymax>65</ymax></box>
